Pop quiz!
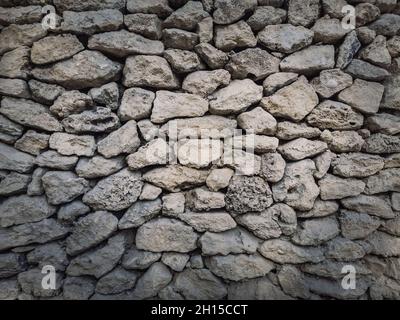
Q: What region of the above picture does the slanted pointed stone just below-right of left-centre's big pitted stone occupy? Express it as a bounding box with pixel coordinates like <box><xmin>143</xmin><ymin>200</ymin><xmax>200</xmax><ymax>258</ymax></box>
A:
<box><xmin>118</xmin><ymin>199</ymin><xmax>161</xmax><ymax>230</ymax></box>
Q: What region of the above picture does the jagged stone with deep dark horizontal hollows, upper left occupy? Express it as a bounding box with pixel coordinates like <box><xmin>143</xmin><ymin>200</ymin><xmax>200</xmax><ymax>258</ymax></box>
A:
<box><xmin>62</xmin><ymin>107</ymin><xmax>120</xmax><ymax>133</ymax></box>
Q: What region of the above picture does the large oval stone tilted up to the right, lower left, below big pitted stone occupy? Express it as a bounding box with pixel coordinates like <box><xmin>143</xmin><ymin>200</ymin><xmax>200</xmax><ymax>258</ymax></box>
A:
<box><xmin>66</xmin><ymin>211</ymin><xmax>118</xmax><ymax>256</ymax></box>
